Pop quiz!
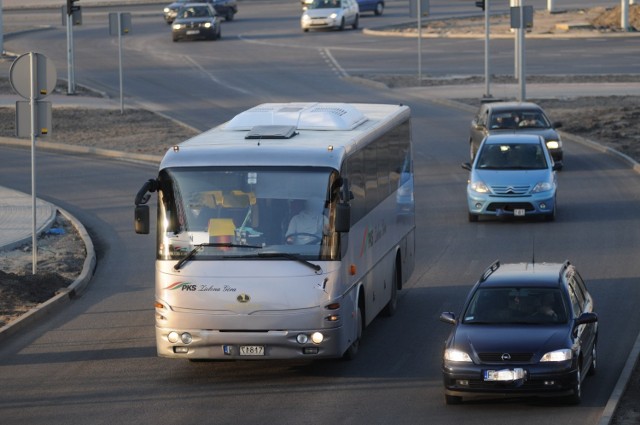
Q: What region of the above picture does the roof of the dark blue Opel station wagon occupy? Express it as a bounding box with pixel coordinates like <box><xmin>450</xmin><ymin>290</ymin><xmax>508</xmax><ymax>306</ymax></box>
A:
<box><xmin>478</xmin><ymin>262</ymin><xmax>572</xmax><ymax>288</ymax></box>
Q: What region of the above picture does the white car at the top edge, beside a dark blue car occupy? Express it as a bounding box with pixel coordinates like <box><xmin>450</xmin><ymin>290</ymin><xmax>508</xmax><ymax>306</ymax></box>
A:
<box><xmin>300</xmin><ymin>0</ymin><xmax>360</xmax><ymax>32</ymax></box>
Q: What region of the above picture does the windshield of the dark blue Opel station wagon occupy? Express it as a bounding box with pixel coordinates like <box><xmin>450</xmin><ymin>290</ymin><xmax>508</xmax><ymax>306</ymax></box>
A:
<box><xmin>462</xmin><ymin>287</ymin><xmax>567</xmax><ymax>325</ymax></box>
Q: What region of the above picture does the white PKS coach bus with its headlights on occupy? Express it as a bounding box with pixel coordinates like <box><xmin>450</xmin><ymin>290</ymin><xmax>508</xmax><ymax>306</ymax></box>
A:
<box><xmin>135</xmin><ymin>103</ymin><xmax>415</xmax><ymax>360</ymax></box>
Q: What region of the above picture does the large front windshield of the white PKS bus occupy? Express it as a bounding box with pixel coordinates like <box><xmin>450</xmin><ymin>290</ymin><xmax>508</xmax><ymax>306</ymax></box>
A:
<box><xmin>158</xmin><ymin>167</ymin><xmax>340</xmax><ymax>261</ymax></box>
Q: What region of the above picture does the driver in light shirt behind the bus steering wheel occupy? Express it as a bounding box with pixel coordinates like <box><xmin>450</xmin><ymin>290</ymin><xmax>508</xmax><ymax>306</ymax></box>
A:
<box><xmin>285</xmin><ymin>199</ymin><xmax>329</xmax><ymax>245</ymax></box>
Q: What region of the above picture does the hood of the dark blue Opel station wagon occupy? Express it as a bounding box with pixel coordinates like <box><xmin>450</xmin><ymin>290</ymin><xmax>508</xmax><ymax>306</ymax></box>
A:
<box><xmin>451</xmin><ymin>325</ymin><xmax>571</xmax><ymax>359</ymax></box>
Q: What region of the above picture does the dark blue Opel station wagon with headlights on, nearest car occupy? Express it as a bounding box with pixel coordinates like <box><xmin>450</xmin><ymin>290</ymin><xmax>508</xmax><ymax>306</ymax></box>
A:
<box><xmin>440</xmin><ymin>261</ymin><xmax>598</xmax><ymax>404</ymax></box>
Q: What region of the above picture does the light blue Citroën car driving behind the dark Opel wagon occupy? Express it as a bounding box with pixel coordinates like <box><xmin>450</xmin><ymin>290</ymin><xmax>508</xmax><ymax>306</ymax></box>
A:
<box><xmin>462</xmin><ymin>133</ymin><xmax>558</xmax><ymax>221</ymax></box>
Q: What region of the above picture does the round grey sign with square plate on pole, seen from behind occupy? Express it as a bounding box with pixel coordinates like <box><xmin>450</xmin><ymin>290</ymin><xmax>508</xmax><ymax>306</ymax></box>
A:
<box><xmin>9</xmin><ymin>52</ymin><xmax>58</xmax><ymax>274</ymax></box>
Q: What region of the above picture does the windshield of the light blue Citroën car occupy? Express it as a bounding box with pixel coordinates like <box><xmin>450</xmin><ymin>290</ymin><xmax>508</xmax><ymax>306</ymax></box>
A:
<box><xmin>476</xmin><ymin>143</ymin><xmax>547</xmax><ymax>170</ymax></box>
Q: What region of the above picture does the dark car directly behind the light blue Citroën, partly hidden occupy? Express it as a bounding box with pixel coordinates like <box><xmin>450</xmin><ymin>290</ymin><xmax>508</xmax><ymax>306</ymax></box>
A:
<box><xmin>469</xmin><ymin>102</ymin><xmax>563</xmax><ymax>169</ymax></box>
